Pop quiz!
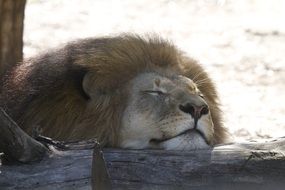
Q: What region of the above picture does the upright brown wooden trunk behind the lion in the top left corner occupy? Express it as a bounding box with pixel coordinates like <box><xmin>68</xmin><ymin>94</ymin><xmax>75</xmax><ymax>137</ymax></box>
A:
<box><xmin>0</xmin><ymin>0</ymin><xmax>26</xmax><ymax>78</ymax></box>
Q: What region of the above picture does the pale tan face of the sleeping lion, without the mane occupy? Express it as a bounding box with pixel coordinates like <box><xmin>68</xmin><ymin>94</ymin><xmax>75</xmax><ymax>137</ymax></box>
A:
<box><xmin>119</xmin><ymin>73</ymin><xmax>214</xmax><ymax>150</ymax></box>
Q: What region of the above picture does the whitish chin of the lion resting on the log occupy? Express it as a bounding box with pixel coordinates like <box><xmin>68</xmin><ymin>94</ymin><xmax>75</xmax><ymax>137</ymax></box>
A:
<box><xmin>153</xmin><ymin>131</ymin><xmax>211</xmax><ymax>150</ymax></box>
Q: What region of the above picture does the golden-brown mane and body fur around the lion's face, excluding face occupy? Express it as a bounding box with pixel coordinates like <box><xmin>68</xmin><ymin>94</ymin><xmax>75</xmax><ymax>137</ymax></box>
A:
<box><xmin>0</xmin><ymin>35</ymin><xmax>225</xmax><ymax>146</ymax></box>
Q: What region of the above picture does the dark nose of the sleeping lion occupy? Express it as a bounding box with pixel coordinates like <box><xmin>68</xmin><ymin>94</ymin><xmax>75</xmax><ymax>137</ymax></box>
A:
<box><xmin>179</xmin><ymin>103</ymin><xmax>209</xmax><ymax>119</ymax></box>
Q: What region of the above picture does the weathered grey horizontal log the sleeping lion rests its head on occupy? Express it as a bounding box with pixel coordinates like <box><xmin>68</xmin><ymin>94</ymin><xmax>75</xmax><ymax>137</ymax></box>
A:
<box><xmin>0</xmin><ymin>138</ymin><xmax>285</xmax><ymax>190</ymax></box>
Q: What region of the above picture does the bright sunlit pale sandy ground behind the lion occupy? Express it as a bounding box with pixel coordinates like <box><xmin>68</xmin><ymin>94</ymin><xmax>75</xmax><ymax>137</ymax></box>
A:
<box><xmin>24</xmin><ymin>0</ymin><xmax>285</xmax><ymax>140</ymax></box>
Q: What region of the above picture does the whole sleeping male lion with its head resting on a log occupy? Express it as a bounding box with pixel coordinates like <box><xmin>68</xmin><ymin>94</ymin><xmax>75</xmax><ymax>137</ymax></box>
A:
<box><xmin>0</xmin><ymin>34</ymin><xmax>227</xmax><ymax>150</ymax></box>
